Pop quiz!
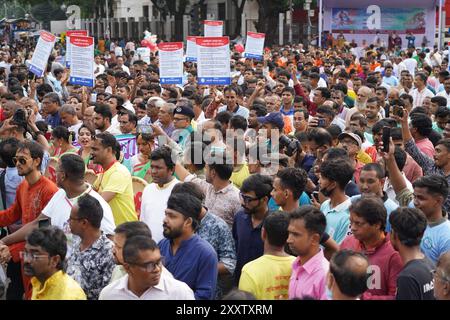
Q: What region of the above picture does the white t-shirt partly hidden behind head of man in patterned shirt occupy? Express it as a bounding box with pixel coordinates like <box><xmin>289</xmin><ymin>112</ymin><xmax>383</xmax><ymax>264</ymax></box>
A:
<box><xmin>42</xmin><ymin>186</ymin><xmax>116</xmax><ymax>234</ymax></box>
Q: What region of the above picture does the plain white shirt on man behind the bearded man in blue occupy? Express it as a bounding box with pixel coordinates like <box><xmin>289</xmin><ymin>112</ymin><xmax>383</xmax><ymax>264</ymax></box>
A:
<box><xmin>139</xmin><ymin>178</ymin><xmax>180</xmax><ymax>243</ymax></box>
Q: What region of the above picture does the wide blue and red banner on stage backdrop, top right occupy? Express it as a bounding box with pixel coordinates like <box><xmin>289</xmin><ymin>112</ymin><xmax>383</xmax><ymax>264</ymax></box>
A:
<box><xmin>331</xmin><ymin>5</ymin><xmax>427</xmax><ymax>34</ymax></box>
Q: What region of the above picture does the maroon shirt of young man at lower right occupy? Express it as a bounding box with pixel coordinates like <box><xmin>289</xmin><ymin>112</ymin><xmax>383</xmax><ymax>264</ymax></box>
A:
<box><xmin>340</xmin><ymin>235</ymin><xmax>403</xmax><ymax>300</ymax></box>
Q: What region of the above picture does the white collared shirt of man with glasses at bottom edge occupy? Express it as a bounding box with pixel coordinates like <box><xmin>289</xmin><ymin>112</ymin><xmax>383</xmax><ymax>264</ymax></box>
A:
<box><xmin>98</xmin><ymin>272</ymin><xmax>195</xmax><ymax>300</ymax></box>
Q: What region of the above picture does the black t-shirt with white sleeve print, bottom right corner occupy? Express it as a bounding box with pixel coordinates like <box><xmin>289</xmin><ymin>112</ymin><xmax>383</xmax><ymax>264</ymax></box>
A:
<box><xmin>396</xmin><ymin>258</ymin><xmax>434</xmax><ymax>300</ymax></box>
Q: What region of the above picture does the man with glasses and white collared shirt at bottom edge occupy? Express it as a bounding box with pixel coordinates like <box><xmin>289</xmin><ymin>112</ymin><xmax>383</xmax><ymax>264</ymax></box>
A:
<box><xmin>99</xmin><ymin>235</ymin><xmax>194</xmax><ymax>300</ymax></box>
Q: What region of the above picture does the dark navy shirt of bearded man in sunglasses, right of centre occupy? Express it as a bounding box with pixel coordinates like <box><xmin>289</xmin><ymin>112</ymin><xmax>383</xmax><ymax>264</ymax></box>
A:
<box><xmin>233</xmin><ymin>209</ymin><xmax>264</xmax><ymax>283</ymax></box>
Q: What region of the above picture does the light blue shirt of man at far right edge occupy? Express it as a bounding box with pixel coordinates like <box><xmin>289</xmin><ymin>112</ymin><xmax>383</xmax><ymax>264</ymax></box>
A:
<box><xmin>420</xmin><ymin>219</ymin><xmax>450</xmax><ymax>264</ymax></box>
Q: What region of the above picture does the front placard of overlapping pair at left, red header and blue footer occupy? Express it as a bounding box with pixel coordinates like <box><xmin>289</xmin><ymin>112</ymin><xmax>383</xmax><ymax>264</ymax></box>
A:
<box><xmin>69</xmin><ymin>36</ymin><xmax>94</xmax><ymax>87</ymax></box>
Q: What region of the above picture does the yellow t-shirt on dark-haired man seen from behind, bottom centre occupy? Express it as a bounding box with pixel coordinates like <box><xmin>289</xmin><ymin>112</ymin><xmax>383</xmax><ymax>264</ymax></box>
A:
<box><xmin>239</xmin><ymin>254</ymin><xmax>295</xmax><ymax>300</ymax></box>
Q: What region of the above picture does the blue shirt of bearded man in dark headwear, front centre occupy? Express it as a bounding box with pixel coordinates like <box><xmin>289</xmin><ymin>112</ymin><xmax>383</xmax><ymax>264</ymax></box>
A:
<box><xmin>158</xmin><ymin>235</ymin><xmax>217</xmax><ymax>300</ymax></box>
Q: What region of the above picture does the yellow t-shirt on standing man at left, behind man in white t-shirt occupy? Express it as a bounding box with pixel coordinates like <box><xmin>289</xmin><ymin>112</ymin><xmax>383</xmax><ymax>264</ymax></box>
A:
<box><xmin>94</xmin><ymin>162</ymin><xmax>137</xmax><ymax>226</ymax></box>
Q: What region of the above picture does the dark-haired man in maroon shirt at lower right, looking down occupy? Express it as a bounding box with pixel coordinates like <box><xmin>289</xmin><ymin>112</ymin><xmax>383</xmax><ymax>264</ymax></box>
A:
<box><xmin>340</xmin><ymin>196</ymin><xmax>403</xmax><ymax>300</ymax></box>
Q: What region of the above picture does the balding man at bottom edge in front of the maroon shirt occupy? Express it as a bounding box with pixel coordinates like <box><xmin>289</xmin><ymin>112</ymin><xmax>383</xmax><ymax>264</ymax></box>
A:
<box><xmin>327</xmin><ymin>249</ymin><xmax>369</xmax><ymax>300</ymax></box>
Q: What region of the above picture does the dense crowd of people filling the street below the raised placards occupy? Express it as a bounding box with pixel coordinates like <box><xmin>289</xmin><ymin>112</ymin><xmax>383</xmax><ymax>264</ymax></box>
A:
<box><xmin>0</xmin><ymin>32</ymin><xmax>450</xmax><ymax>300</ymax></box>
